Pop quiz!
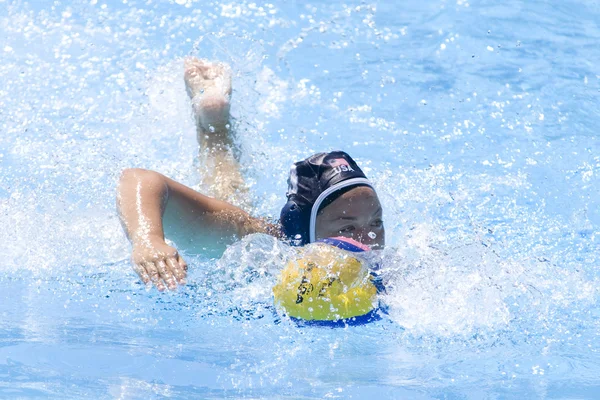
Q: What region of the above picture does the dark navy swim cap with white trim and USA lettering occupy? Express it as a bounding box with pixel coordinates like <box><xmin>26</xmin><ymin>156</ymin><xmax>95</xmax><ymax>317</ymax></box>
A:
<box><xmin>280</xmin><ymin>151</ymin><xmax>373</xmax><ymax>246</ymax></box>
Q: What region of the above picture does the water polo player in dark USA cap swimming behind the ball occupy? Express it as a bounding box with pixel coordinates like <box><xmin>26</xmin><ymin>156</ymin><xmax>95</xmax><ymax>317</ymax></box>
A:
<box><xmin>117</xmin><ymin>59</ymin><xmax>385</xmax><ymax>290</ymax></box>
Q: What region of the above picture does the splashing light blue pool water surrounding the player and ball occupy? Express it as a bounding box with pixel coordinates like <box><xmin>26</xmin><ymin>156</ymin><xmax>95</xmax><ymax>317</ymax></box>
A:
<box><xmin>0</xmin><ymin>0</ymin><xmax>600</xmax><ymax>399</ymax></box>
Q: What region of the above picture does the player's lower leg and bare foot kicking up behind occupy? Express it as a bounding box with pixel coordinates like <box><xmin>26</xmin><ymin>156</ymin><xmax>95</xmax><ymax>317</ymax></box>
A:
<box><xmin>184</xmin><ymin>57</ymin><xmax>249</xmax><ymax>207</ymax></box>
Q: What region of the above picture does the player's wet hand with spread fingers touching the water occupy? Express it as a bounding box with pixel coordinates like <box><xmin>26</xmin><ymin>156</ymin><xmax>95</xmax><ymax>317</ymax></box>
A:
<box><xmin>131</xmin><ymin>237</ymin><xmax>187</xmax><ymax>292</ymax></box>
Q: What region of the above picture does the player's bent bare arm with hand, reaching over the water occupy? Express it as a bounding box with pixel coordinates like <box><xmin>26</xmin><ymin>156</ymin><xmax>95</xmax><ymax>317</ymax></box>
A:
<box><xmin>117</xmin><ymin>168</ymin><xmax>279</xmax><ymax>289</ymax></box>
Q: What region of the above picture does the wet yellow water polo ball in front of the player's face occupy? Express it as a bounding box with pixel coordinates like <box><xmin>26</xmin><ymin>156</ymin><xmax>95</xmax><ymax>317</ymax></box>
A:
<box><xmin>273</xmin><ymin>243</ymin><xmax>377</xmax><ymax>321</ymax></box>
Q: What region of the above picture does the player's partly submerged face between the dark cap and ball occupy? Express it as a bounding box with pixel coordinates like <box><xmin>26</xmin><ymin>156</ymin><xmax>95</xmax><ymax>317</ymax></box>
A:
<box><xmin>315</xmin><ymin>186</ymin><xmax>385</xmax><ymax>249</ymax></box>
